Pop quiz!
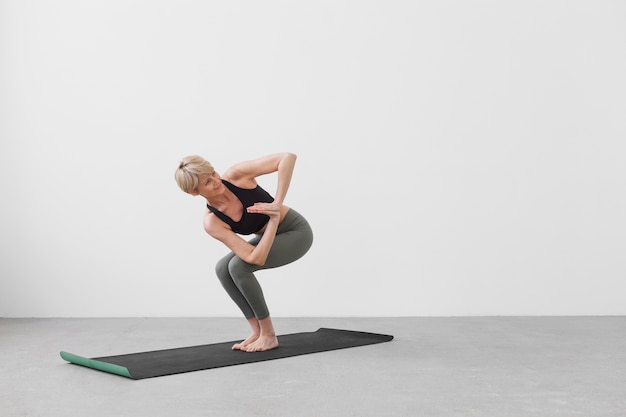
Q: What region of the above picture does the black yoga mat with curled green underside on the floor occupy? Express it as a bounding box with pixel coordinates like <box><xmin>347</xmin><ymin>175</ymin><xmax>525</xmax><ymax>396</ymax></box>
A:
<box><xmin>61</xmin><ymin>328</ymin><xmax>393</xmax><ymax>379</ymax></box>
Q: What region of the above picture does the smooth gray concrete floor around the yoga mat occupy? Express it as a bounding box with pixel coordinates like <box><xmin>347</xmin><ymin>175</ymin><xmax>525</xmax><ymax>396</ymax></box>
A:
<box><xmin>0</xmin><ymin>317</ymin><xmax>626</xmax><ymax>417</ymax></box>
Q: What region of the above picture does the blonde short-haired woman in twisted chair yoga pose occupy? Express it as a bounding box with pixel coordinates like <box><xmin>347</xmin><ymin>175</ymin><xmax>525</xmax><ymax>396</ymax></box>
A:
<box><xmin>175</xmin><ymin>152</ymin><xmax>313</xmax><ymax>352</ymax></box>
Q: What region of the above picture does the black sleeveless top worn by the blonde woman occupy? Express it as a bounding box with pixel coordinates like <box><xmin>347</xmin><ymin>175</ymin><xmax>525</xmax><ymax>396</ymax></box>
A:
<box><xmin>206</xmin><ymin>180</ymin><xmax>274</xmax><ymax>235</ymax></box>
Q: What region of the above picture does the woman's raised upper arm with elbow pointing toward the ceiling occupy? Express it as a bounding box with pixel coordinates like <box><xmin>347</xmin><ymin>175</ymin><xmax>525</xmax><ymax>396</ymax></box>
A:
<box><xmin>223</xmin><ymin>152</ymin><xmax>297</xmax><ymax>206</ymax></box>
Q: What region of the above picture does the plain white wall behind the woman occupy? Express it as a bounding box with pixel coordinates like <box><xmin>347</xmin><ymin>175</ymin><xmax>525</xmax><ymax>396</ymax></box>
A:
<box><xmin>0</xmin><ymin>0</ymin><xmax>626</xmax><ymax>317</ymax></box>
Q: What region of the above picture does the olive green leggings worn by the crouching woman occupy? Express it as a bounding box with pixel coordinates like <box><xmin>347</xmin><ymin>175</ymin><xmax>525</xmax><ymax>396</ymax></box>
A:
<box><xmin>215</xmin><ymin>208</ymin><xmax>313</xmax><ymax>320</ymax></box>
